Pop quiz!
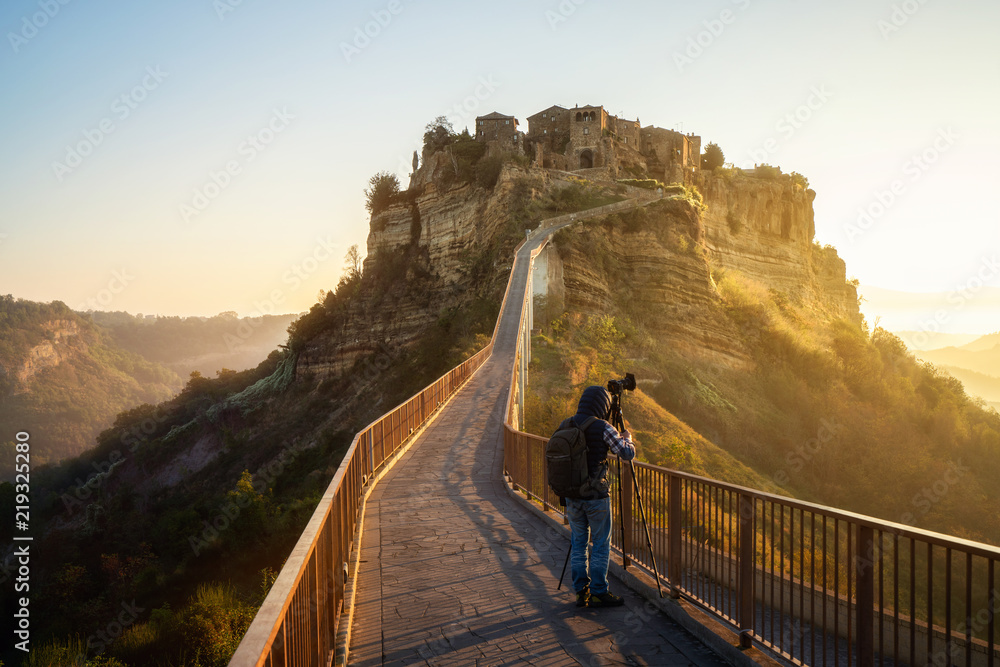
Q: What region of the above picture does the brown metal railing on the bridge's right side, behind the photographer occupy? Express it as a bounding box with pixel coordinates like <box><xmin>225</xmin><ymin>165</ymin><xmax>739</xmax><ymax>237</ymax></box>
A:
<box><xmin>504</xmin><ymin>249</ymin><xmax>1000</xmax><ymax>667</ymax></box>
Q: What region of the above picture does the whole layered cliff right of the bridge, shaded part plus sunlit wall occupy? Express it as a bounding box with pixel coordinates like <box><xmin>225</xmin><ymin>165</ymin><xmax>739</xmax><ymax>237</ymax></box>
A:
<box><xmin>540</xmin><ymin>175</ymin><xmax>860</xmax><ymax>368</ymax></box>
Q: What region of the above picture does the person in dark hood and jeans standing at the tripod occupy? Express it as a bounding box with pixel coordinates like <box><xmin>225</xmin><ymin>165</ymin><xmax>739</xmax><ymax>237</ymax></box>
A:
<box><xmin>560</xmin><ymin>386</ymin><xmax>635</xmax><ymax>607</ymax></box>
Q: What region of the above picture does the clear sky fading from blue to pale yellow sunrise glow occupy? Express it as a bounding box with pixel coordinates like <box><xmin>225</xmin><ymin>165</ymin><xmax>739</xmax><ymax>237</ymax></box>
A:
<box><xmin>0</xmin><ymin>0</ymin><xmax>1000</xmax><ymax>333</ymax></box>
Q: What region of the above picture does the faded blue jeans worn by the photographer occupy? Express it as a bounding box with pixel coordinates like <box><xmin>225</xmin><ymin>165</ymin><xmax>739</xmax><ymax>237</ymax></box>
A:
<box><xmin>566</xmin><ymin>498</ymin><xmax>611</xmax><ymax>595</ymax></box>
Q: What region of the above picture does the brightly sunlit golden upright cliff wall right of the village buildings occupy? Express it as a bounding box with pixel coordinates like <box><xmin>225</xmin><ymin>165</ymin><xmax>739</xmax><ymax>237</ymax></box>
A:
<box><xmin>695</xmin><ymin>172</ymin><xmax>860</xmax><ymax>319</ymax></box>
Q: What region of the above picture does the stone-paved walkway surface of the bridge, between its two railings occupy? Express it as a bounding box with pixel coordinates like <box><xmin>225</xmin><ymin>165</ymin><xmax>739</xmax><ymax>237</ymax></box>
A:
<box><xmin>349</xmin><ymin>211</ymin><xmax>725</xmax><ymax>665</ymax></box>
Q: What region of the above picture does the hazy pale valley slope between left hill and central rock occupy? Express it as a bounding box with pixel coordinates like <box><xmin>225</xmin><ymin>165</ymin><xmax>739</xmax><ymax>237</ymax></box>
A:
<box><xmin>86</xmin><ymin>311</ymin><xmax>298</xmax><ymax>378</ymax></box>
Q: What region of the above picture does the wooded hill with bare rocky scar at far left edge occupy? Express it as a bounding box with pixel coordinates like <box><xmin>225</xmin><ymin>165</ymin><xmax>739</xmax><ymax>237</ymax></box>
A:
<box><xmin>0</xmin><ymin>295</ymin><xmax>184</xmax><ymax>480</ymax></box>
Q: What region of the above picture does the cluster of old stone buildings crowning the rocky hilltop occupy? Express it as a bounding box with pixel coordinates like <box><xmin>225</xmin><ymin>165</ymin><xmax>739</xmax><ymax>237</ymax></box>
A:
<box><xmin>475</xmin><ymin>105</ymin><xmax>701</xmax><ymax>183</ymax></box>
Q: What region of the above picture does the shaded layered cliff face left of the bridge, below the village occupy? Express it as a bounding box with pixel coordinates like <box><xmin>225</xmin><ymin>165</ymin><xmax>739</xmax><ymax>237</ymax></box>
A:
<box><xmin>298</xmin><ymin>164</ymin><xmax>525</xmax><ymax>376</ymax></box>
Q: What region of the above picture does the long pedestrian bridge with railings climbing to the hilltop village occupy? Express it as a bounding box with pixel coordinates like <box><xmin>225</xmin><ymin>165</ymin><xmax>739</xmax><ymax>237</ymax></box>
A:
<box><xmin>230</xmin><ymin>199</ymin><xmax>1000</xmax><ymax>667</ymax></box>
